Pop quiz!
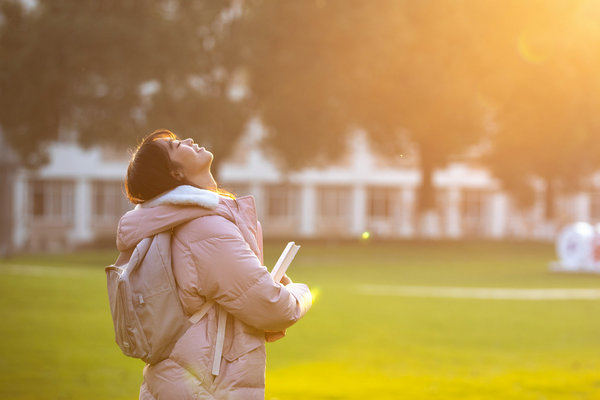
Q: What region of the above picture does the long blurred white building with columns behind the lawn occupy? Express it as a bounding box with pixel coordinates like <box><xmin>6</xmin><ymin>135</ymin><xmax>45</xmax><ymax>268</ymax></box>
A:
<box><xmin>7</xmin><ymin>125</ymin><xmax>600</xmax><ymax>250</ymax></box>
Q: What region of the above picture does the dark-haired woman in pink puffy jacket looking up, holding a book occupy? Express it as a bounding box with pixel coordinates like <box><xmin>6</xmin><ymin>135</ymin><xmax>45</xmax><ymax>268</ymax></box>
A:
<box><xmin>117</xmin><ymin>130</ymin><xmax>312</xmax><ymax>400</ymax></box>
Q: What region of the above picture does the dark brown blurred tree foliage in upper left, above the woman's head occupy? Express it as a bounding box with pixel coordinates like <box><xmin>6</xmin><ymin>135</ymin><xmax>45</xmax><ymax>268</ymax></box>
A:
<box><xmin>0</xmin><ymin>0</ymin><xmax>246</xmax><ymax>170</ymax></box>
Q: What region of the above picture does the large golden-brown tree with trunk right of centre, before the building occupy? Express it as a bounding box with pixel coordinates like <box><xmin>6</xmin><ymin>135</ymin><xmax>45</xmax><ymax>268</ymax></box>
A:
<box><xmin>234</xmin><ymin>0</ymin><xmax>484</xmax><ymax>219</ymax></box>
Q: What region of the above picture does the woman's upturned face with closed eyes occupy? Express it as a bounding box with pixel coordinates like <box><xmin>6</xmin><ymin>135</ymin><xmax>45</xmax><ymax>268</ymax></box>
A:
<box><xmin>159</xmin><ymin>138</ymin><xmax>213</xmax><ymax>180</ymax></box>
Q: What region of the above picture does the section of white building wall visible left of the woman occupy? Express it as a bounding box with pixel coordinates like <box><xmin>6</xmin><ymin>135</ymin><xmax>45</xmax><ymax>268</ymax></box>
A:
<box><xmin>13</xmin><ymin>144</ymin><xmax>131</xmax><ymax>251</ymax></box>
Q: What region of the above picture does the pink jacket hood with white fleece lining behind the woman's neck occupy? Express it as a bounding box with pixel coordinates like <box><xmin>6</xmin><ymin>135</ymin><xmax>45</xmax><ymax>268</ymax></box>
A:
<box><xmin>117</xmin><ymin>185</ymin><xmax>244</xmax><ymax>252</ymax></box>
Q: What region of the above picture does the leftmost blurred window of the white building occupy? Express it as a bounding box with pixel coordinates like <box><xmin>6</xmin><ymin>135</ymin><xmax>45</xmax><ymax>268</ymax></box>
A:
<box><xmin>29</xmin><ymin>179</ymin><xmax>74</xmax><ymax>222</ymax></box>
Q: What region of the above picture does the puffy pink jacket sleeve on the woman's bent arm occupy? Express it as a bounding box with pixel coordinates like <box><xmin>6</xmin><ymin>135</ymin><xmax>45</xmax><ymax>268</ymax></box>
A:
<box><xmin>189</xmin><ymin>216</ymin><xmax>312</xmax><ymax>331</ymax></box>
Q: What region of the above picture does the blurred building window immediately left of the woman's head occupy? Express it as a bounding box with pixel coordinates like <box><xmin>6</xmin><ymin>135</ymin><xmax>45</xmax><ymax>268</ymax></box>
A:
<box><xmin>92</xmin><ymin>181</ymin><xmax>132</xmax><ymax>219</ymax></box>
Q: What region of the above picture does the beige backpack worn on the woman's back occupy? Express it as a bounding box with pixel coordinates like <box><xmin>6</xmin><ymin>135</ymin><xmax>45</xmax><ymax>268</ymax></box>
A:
<box><xmin>106</xmin><ymin>232</ymin><xmax>197</xmax><ymax>364</ymax></box>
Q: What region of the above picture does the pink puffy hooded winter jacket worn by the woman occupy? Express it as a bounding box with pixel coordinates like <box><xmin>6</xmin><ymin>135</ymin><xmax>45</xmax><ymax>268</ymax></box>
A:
<box><xmin>117</xmin><ymin>191</ymin><xmax>311</xmax><ymax>400</ymax></box>
